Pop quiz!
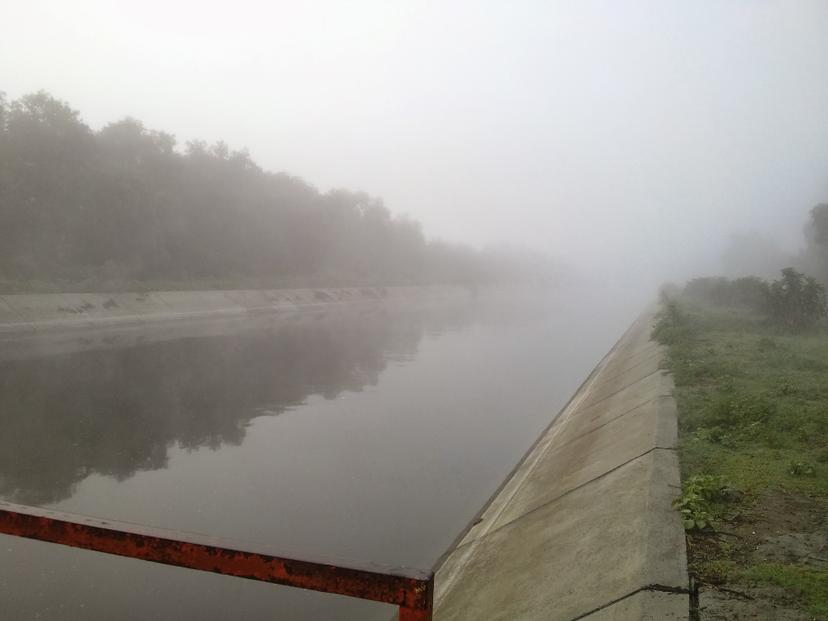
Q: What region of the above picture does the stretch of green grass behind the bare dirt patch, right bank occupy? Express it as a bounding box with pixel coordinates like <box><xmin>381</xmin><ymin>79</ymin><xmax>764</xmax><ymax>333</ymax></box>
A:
<box><xmin>657</xmin><ymin>307</ymin><xmax>828</xmax><ymax>496</ymax></box>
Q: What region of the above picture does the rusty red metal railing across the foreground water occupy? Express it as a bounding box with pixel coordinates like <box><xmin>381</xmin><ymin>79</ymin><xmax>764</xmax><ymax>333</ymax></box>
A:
<box><xmin>0</xmin><ymin>502</ymin><xmax>434</xmax><ymax>621</ymax></box>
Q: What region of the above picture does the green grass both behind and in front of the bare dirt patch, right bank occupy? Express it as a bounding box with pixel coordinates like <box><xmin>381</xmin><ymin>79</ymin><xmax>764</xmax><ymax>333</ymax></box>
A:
<box><xmin>653</xmin><ymin>301</ymin><xmax>828</xmax><ymax>618</ymax></box>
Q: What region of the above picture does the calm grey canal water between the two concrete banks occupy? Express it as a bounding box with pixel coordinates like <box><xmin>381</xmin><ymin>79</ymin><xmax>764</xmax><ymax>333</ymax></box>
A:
<box><xmin>0</xmin><ymin>294</ymin><xmax>634</xmax><ymax>621</ymax></box>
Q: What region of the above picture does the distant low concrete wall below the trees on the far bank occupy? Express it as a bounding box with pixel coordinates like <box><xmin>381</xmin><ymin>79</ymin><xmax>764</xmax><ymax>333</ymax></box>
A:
<box><xmin>0</xmin><ymin>286</ymin><xmax>465</xmax><ymax>332</ymax></box>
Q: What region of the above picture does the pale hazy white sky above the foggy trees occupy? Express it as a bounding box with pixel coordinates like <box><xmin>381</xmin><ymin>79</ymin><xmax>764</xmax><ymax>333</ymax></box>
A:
<box><xmin>0</xmin><ymin>0</ymin><xmax>828</xmax><ymax>284</ymax></box>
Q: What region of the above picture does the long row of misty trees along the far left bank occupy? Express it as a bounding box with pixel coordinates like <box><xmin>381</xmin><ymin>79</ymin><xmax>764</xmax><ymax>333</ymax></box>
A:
<box><xmin>0</xmin><ymin>91</ymin><xmax>554</xmax><ymax>289</ymax></box>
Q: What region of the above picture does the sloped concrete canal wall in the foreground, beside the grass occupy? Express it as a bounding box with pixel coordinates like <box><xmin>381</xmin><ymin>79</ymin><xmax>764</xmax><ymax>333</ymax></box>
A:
<box><xmin>435</xmin><ymin>314</ymin><xmax>689</xmax><ymax>621</ymax></box>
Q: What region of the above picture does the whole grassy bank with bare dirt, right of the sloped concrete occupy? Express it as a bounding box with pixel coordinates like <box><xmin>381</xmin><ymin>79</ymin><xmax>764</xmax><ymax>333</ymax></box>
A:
<box><xmin>654</xmin><ymin>299</ymin><xmax>828</xmax><ymax>620</ymax></box>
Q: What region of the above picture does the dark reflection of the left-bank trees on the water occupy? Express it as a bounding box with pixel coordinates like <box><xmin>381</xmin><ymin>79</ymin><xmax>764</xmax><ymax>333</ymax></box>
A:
<box><xmin>0</xmin><ymin>303</ymin><xmax>469</xmax><ymax>504</ymax></box>
